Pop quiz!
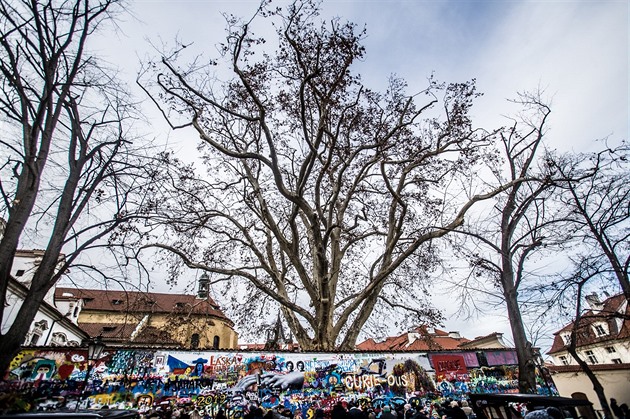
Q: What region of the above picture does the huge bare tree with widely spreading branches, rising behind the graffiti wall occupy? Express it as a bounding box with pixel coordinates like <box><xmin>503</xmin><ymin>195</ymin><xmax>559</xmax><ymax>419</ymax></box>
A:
<box><xmin>140</xmin><ymin>1</ymin><xmax>521</xmax><ymax>350</ymax></box>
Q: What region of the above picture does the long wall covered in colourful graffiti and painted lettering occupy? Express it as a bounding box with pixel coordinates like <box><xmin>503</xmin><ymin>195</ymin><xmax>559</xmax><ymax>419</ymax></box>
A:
<box><xmin>0</xmin><ymin>348</ymin><xmax>556</xmax><ymax>418</ymax></box>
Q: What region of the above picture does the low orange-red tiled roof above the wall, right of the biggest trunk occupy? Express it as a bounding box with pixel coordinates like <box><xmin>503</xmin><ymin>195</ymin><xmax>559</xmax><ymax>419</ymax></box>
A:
<box><xmin>356</xmin><ymin>327</ymin><xmax>469</xmax><ymax>351</ymax></box>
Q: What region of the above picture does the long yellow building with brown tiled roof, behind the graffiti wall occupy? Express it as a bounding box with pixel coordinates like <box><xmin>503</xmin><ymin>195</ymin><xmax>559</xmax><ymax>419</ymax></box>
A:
<box><xmin>55</xmin><ymin>287</ymin><xmax>238</xmax><ymax>349</ymax></box>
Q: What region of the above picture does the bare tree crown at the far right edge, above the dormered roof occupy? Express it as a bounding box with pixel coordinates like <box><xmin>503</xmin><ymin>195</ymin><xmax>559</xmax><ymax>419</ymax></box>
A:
<box><xmin>553</xmin><ymin>143</ymin><xmax>630</xmax><ymax>303</ymax></box>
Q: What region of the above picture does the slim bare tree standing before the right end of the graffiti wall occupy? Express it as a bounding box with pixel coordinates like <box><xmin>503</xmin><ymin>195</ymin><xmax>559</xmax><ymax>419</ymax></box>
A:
<box><xmin>456</xmin><ymin>94</ymin><xmax>564</xmax><ymax>393</ymax></box>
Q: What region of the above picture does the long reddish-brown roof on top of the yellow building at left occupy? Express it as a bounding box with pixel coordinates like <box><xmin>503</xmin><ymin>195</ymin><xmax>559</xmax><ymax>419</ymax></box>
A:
<box><xmin>55</xmin><ymin>287</ymin><xmax>232</xmax><ymax>325</ymax></box>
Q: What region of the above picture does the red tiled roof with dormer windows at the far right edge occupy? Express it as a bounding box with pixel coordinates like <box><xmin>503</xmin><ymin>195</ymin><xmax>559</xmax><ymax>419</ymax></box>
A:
<box><xmin>547</xmin><ymin>294</ymin><xmax>630</xmax><ymax>354</ymax></box>
